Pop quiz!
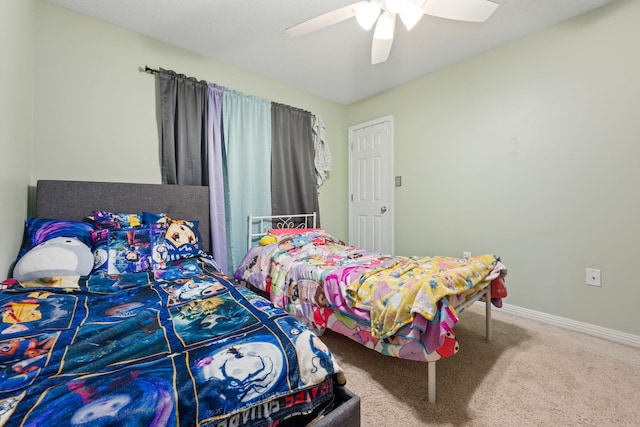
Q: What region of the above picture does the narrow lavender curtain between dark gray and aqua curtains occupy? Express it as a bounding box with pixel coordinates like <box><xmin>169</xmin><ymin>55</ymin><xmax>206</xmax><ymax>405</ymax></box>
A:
<box><xmin>207</xmin><ymin>83</ymin><xmax>233</xmax><ymax>274</ymax></box>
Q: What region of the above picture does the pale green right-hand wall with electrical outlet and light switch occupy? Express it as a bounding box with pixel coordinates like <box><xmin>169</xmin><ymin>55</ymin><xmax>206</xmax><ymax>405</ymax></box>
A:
<box><xmin>348</xmin><ymin>0</ymin><xmax>640</xmax><ymax>335</ymax></box>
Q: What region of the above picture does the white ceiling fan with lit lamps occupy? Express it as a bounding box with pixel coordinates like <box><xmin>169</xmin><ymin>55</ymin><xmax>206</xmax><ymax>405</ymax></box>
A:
<box><xmin>286</xmin><ymin>0</ymin><xmax>498</xmax><ymax>64</ymax></box>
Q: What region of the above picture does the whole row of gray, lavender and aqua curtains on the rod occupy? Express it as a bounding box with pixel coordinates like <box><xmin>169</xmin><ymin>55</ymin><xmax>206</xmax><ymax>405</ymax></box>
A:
<box><xmin>158</xmin><ymin>68</ymin><xmax>322</xmax><ymax>275</ymax></box>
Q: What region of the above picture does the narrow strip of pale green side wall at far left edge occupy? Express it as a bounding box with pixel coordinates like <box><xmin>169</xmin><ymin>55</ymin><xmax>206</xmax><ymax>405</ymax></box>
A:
<box><xmin>0</xmin><ymin>0</ymin><xmax>35</xmax><ymax>280</ymax></box>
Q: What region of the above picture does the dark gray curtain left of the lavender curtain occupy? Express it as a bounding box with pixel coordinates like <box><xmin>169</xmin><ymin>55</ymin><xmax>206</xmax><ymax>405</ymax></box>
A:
<box><xmin>158</xmin><ymin>68</ymin><xmax>209</xmax><ymax>185</ymax></box>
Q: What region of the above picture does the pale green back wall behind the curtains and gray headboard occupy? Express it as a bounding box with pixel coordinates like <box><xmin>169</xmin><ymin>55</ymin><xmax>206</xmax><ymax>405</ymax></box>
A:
<box><xmin>31</xmin><ymin>1</ymin><xmax>348</xmax><ymax>236</ymax></box>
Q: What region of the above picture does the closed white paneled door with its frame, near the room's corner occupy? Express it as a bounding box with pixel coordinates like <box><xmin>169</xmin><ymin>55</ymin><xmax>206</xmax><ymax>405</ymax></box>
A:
<box><xmin>349</xmin><ymin>116</ymin><xmax>394</xmax><ymax>255</ymax></box>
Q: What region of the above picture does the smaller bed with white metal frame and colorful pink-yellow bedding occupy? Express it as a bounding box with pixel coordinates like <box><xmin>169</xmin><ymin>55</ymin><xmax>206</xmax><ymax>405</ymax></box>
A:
<box><xmin>234</xmin><ymin>214</ymin><xmax>506</xmax><ymax>403</ymax></box>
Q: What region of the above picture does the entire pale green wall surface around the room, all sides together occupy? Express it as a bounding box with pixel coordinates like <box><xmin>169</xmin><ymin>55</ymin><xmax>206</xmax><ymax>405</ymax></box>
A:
<box><xmin>0</xmin><ymin>0</ymin><xmax>640</xmax><ymax>335</ymax></box>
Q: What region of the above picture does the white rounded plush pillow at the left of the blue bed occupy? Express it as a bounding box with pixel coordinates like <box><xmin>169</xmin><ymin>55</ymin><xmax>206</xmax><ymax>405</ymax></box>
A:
<box><xmin>13</xmin><ymin>237</ymin><xmax>93</xmax><ymax>282</ymax></box>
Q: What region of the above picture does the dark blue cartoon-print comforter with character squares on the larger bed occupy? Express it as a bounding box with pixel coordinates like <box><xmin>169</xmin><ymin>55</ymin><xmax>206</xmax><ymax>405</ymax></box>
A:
<box><xmin>0</xmin><ymin>263</ymin><xmax>340</xmax><ymax>426</ymax></box>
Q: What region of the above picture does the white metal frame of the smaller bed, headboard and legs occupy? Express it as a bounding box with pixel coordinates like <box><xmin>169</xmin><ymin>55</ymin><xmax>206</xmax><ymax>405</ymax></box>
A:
<box><xmin>247</xmin><ymin>212</ymin><xmax>493</xmax><ymax>403</ymax></box>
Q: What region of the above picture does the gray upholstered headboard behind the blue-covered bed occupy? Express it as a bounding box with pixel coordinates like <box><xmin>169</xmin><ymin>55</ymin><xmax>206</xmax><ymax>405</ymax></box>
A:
<box><xmin>36</xmin><ymin>180</ymin><xmax>211</xmax><ymax>253</ymax></box>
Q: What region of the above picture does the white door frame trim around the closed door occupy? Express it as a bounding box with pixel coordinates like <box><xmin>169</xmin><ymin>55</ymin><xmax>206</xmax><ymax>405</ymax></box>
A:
<box><xmin>348</xmin><ymin>115</ymin><xmax>395</xmax><ymax>255</ymax></box>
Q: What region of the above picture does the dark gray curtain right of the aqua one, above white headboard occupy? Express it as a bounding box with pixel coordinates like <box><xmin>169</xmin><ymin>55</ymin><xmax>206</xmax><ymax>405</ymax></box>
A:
<box><xmin>271</xmin><ymin>102</ymin><xmax>320</xmax><ymax>226</ymax></box>
